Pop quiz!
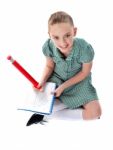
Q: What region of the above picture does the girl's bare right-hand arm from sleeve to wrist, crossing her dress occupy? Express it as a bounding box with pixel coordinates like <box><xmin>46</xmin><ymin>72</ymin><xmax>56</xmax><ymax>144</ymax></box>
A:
<box><xmin>61</xmin><ymin>62</ymin><xmax>92</xmax><ymax>89</ymax></box>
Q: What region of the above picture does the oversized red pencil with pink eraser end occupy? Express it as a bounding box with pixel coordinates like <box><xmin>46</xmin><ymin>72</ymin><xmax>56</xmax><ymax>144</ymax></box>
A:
<box><xmin>7</xmin><ymin>56</ymin><xmax>41</xmax><ymax>89</ymax></box>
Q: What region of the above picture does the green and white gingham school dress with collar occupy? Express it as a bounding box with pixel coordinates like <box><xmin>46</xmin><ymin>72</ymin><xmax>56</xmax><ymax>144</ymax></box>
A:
<box><xmin>42</xmin><ymin>38</ymin><xmax>98</xmax><ymax>109</ymax></box>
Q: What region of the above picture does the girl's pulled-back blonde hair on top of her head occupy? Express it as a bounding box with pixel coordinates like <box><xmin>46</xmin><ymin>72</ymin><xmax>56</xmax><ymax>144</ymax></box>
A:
<box><xmin>48</xmin><ymin>11</ymin><xmax>74</xmax><ymax>28</ymax></box>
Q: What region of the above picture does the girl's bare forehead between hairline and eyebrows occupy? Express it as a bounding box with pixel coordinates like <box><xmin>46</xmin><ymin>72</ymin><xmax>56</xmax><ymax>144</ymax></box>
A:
<box><xmin>49</xmin><ymin>23</ymin><xmax>74</xmax><ymax>35</ymax></box>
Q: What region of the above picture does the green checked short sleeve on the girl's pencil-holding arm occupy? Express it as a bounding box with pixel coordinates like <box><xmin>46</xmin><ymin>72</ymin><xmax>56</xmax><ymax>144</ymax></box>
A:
<box><xmin>42</xmin><ymin>39</ymin><xmax>53</xmax><ymax>57</ymax></box>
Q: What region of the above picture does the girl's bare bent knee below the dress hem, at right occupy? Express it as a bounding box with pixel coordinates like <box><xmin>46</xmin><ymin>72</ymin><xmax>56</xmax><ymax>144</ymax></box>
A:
<box><xmin>82</xmin><ymin>100</ymin><xmax>101</xmax><ymax>120</ymax></box>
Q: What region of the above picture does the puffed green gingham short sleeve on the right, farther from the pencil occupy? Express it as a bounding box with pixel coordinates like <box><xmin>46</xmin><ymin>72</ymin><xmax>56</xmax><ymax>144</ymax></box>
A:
<box><xmin>80</xmin><ymin>39</ymin><xmax>94</xmax><ymax>63</ymax></box>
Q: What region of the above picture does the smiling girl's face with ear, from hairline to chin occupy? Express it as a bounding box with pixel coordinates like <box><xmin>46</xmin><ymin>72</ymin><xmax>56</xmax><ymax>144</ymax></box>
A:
<box><xmin>49</xmin><ymin>23</ymin><xmax>77</xmax><ymax>55</ymax></box>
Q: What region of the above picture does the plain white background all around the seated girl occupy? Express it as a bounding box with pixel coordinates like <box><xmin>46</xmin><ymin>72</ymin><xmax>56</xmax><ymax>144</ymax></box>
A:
<box><xmin>0</xmin><ymin>0</ymin><xmax>113</xmax><ymax>150</ymax></box>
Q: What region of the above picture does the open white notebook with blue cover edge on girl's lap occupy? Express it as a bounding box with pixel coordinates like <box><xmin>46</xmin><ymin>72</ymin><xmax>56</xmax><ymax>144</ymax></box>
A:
<box><xmin>18</xmin><ymin>82</ymin><xmax>56</xmax><ymax>115</ymax></box>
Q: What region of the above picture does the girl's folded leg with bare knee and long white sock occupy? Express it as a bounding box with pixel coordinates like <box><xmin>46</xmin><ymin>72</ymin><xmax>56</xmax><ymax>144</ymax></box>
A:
<box><xmin>49</xmin><ymin>100</ymin><xmax>101</xmax><ymax>120</ymax></box>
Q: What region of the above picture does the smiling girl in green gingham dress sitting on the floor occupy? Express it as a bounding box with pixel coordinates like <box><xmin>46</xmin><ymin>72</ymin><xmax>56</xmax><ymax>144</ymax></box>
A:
<box><xmin>26</xmin><ymin>11</ymin><xmax>101</xmax><ymax>125</ymax></box>
